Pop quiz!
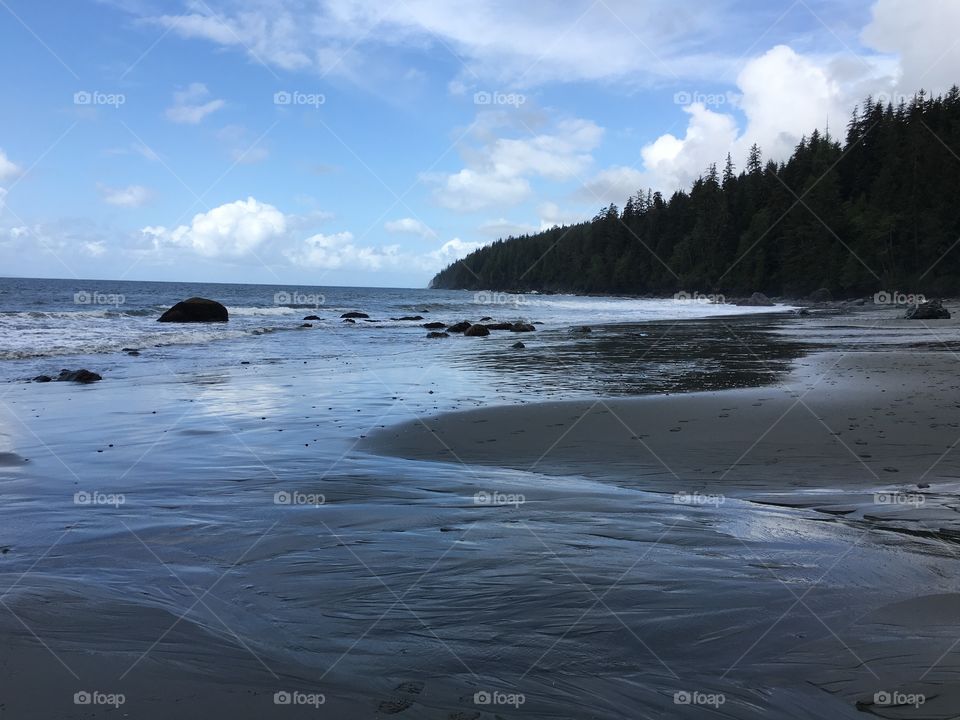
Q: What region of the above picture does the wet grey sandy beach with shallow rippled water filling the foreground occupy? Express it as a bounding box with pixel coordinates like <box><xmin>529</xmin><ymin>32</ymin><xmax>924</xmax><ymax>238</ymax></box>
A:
<box><xmin>0</xmin><ymin>306</ymin><xmax>960</xmax><ymax>720</ymax></box>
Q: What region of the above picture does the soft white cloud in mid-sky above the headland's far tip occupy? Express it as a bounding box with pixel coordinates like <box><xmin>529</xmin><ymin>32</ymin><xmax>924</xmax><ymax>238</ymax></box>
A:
<box><xmin>427</xmin><ymin>119</ymin><xmax>603</xmax><ymax>212</ymax></box>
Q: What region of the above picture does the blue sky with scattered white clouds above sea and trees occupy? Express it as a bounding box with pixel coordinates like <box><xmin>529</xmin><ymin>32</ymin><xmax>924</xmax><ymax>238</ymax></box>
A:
<box><xmin>0</xmin><ymin>0</ymin><xmax>960</xmax><ymax>286</ymax></box>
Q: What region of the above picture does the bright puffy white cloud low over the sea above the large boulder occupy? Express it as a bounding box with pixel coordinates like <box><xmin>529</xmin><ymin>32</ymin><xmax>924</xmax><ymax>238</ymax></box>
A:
<box><xmin>141</xmin><ymin>197</ymin><xmax>287</xmax><ymax>258</ymax></box>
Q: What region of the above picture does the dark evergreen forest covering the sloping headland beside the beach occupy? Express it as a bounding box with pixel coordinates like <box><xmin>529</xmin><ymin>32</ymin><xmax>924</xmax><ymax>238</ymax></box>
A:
<box><xmin>431</xmin><ymin>86</ymin><xmax>960</xmax><ymax>297</ymax></box>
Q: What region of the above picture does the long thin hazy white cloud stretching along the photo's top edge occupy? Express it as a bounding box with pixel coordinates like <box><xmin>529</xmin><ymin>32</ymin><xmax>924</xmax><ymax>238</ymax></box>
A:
<box><xmin>141</xmin><ymin>0</ymin><xmax>736</xmax><ymax>88</ymax></box>
